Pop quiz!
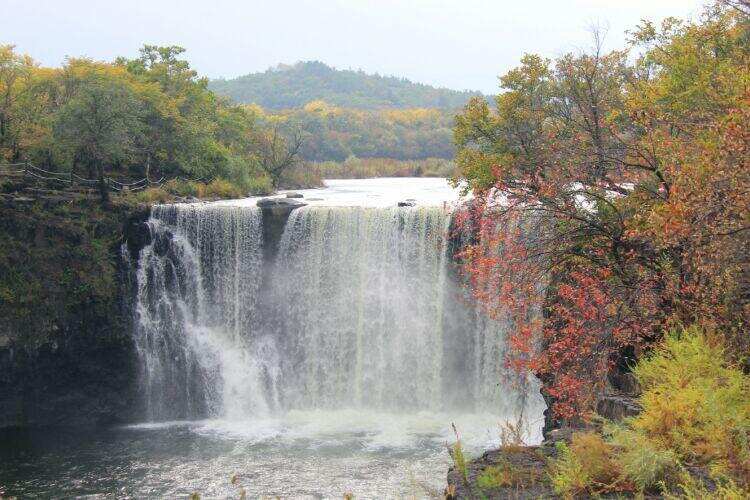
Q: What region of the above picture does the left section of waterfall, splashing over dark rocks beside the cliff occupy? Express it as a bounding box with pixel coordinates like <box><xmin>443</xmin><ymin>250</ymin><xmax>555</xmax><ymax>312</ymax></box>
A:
<box><xmin>135</xmin><ymin>204</ymin><xmax>277</xmax><ymax>420</ymax></box>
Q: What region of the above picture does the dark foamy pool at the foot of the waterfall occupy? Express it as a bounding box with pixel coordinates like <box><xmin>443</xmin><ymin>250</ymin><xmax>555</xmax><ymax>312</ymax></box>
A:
<box><xmin>0</xmin><ymin>410</ymin><xmax>539</xmax><ymax>499</ymax></box>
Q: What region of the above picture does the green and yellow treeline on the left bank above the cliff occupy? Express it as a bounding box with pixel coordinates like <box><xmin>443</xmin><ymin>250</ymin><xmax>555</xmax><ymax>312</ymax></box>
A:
<box><xmin>0</xmin><ymin>45</ymin><xmax>306</xmax><ymax>198</ymax></box>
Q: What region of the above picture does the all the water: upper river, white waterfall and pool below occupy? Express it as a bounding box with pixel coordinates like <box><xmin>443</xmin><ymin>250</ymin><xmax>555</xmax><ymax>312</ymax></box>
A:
<box><xmin>0</xmin><ymin>179</ymin><xmax>544</xmax><ymax>498</ymax></box>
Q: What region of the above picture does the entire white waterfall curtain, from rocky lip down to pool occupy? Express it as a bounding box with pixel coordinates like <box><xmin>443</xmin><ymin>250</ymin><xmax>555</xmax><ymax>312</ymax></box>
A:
<box><xmin>135</xmin><ymin>204</ymin><xmax>543</xmax><ymax>426</ymax></box>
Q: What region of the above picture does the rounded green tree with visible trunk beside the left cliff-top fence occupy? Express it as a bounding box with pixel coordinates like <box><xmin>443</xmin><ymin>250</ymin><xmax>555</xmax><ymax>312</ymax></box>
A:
<box><xmin>55</xmin><ymin>62</ymin><xmax>141</xmax><ymax>204</ymax></box>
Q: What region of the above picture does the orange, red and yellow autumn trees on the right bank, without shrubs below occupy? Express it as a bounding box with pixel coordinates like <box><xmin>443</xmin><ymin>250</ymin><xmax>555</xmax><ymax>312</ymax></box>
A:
<box><xmin>455</xmin><ymin>2</ymin><xmax>750</xmax><ymax>421</ymax></box>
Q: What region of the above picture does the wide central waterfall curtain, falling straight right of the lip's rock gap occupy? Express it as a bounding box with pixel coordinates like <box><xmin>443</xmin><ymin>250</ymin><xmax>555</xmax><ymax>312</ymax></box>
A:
<box><xmin>275</xmin><ymin>207</ymin><xmax>448</xmax><ymax>410</ymax></box>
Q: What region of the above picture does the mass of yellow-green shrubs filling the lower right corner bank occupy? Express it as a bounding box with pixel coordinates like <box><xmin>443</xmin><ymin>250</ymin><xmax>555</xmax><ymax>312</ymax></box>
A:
<box><xmin>550</xmin><ymin>327</ymin><xmax>750</xmax><ymax>499</ymax></box>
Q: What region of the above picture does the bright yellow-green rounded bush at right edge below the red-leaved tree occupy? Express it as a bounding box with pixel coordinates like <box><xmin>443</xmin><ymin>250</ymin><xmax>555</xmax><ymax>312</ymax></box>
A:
<box><xmin>629</xmin><ymin>327</ymin><xmax>750</xmax><ymax>483</ymax></box>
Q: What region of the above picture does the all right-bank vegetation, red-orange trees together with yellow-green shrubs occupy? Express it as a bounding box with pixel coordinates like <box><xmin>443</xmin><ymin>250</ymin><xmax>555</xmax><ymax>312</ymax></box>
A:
<box><xmin>454</xmin><ymin>0</ymin><xmax>750</xmax><ymax>498</ymax></box>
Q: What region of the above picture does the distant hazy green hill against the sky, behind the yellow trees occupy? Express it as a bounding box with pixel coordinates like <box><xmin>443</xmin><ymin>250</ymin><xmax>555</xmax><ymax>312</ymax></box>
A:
<box><xmin>209</xmin><ymin>61</ymin><xmax>481</xmax><ymax>110</ymax></box>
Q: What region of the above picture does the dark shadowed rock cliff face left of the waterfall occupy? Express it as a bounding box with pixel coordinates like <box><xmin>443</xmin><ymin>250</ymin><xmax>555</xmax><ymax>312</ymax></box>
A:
<box><xmin>0</xmin><ymin>199</ymin><xmax>149</xmax><ymax>427</ymax></box>
